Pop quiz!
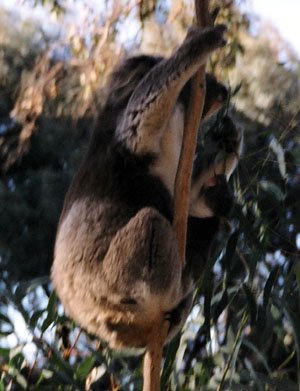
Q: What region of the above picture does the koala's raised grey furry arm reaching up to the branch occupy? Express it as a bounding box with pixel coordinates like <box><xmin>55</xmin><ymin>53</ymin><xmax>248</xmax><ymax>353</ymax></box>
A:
<box><xmin>117</xmin><ymin>25</ymin><xmax>226</xmax><ymax>155</ymax></box>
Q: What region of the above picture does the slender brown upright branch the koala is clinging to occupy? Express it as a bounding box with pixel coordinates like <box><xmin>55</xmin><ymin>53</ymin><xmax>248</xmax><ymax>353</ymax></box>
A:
<box><xmin>143</xmin><ymin>0</ymin><xmax>210</xmax><ymax>391</ymax></box>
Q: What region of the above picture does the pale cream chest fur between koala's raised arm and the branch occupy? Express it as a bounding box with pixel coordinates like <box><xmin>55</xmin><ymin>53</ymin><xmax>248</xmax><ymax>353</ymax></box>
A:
<box><xmin>150</xmin><ymin>104</ymin><xmax>184</xmax><ymax>195</ymax></box>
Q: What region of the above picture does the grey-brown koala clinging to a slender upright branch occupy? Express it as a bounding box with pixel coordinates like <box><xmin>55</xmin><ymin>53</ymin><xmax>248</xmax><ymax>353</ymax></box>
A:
<box><xmin>51</xmin><ymin>25</ymin><xmax>243</xmax><ymax>348</ymax></box>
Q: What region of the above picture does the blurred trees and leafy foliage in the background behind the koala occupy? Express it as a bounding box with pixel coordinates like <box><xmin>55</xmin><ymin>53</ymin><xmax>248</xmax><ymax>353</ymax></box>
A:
<box><xmin>0</xmin><ymin>0</ymin><xmax>300</xmax><ymax>391</ymax></box>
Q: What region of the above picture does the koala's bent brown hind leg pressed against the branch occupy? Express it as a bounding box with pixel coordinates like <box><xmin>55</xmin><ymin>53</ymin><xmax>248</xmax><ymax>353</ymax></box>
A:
<box><xmin>102</xmin><ymin>208</ymin><xmax>181</xmax><ymax>316</ymax></box>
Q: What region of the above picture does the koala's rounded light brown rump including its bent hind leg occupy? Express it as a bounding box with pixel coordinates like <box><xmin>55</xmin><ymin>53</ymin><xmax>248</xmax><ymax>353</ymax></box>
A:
<box><xmin>52</xmin><ymin>199</ymin><xmax>181</xmax><ymax>347</ymax></box>
